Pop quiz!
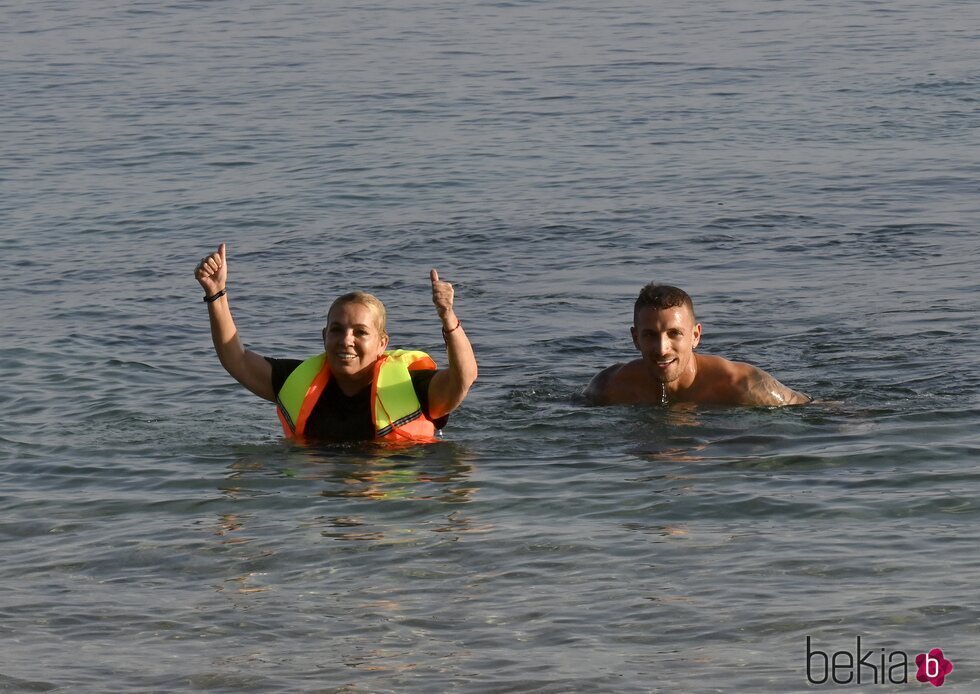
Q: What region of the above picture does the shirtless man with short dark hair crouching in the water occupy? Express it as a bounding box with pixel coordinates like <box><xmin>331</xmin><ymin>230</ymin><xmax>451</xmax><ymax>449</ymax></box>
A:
<box><xmin>585</xmin><ymin>283</ymin><xmax>810</xmax><ymax>407</ymax></box>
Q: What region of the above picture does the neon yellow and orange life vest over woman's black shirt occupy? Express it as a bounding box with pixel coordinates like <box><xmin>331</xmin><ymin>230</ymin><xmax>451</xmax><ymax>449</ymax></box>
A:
<box><xmin>276</xmin><ymin>349</ymin><xmax>436</xmax><ymax>441</ymax></box>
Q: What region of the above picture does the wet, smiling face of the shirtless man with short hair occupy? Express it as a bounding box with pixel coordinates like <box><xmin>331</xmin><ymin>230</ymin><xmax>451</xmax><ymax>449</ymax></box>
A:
<box><xmin>630</xmin><ymin>306</ymin><xmax>701</xmax><ymax>383</ymax></box>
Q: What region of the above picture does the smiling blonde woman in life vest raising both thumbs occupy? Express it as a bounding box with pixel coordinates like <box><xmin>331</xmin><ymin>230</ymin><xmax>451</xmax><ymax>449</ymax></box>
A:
<box><xmin>194</xmin><ymin>244</ymin><xmax>477</xmax><ymax>442</ymax></box>
